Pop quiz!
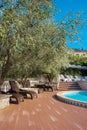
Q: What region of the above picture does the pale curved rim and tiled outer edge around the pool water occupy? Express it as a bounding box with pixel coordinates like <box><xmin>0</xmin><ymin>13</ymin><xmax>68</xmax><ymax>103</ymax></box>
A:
<box><xmin>56</xmin><ymin>90</ymin><xmax>87</xmax><ymax>108</ymax></box>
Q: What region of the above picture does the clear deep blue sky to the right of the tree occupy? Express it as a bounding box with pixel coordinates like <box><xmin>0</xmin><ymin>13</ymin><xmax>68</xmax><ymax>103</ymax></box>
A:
<box><xmin>55</xmin><ymin>0</ymin><xmax>87</xmax><ymax>50</ymax></box>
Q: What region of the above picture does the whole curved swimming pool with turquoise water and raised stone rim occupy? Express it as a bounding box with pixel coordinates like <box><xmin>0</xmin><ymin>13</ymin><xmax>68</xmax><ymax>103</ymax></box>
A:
<box><xmin>57</xmin><ymin>91</ymin><xmax>87</xmax><ymax>108</ymax></box>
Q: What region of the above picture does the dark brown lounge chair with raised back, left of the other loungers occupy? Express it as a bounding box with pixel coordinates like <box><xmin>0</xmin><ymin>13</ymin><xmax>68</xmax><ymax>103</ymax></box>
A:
<box><xmin>9</xmin><ymin>81</ymin><xmax>37</xmax><ymax>99</ymax></box>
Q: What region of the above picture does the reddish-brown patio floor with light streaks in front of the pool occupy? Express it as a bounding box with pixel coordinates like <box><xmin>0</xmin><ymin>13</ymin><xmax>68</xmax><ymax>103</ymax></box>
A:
<box><xmin>0</xmin><ymin>91</ymin><xmax>87</xmax><ymax>130</ymax></box>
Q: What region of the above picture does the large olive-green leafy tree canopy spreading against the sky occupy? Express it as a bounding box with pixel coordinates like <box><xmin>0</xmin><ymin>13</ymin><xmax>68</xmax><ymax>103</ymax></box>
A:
<box><xmin>0</xmin><ymin>0</ymin><xmax>85</xmax><ymax>80</ymax></box>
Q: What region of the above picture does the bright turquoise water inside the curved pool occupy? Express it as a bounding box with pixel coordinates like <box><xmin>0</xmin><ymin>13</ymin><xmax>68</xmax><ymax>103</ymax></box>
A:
<box><xmin>62</xmin><ymin>91</ymin><xmax>87</xmax><ymax>102</ymax></box>
